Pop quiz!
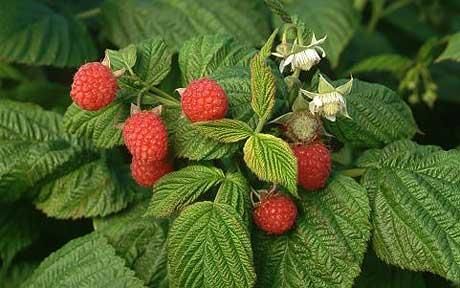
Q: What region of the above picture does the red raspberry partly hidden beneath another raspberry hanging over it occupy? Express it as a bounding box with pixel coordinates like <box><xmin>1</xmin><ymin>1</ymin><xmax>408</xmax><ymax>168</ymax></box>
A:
<box><xmin>131</xmin><ymin>158</ymin><xmax>173</xmax><ymax>187</ymax></box>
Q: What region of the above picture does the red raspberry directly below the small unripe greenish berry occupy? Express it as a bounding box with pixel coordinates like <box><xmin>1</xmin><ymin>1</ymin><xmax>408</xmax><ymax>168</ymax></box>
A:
<box><xmin>292</xmin><ymin>142</ymin><xmax>332</xmax><ymax>190</ymax></box>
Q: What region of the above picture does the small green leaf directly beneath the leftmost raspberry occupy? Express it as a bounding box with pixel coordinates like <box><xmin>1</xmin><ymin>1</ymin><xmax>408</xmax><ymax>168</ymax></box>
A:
<box><xmin>63</xmin><ymin>100</ymin><xmax>129</xmax><ymax>149</ymax></box>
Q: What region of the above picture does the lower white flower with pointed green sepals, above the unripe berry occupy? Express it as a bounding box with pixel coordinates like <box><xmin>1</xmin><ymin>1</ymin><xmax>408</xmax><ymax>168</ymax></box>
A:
<box><xmin>300</xmin><ymin>75</ymin><xmax>353</xmax><ymax>121</ymax></box>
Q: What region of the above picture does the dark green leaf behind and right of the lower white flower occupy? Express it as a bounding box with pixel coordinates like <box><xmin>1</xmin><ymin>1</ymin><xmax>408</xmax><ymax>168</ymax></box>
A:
<box><xmin>326</xmin><ymin>80</ymin><xmax>417</xmax><ymax>147</ymax></box>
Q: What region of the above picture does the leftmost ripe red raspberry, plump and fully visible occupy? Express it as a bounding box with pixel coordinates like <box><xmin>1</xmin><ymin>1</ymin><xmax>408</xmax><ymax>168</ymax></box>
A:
<box><xmin>70</xmin><ymin>62</ymin><xmax>118</xmax><ymax>111</ymax></box>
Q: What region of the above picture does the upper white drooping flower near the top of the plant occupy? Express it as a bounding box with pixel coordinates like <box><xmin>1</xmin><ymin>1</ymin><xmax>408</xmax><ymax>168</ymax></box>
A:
<box><xmin>273</xmin><ymin>33</ymin><xmax>327</xmax><ymax>72</ymax></box>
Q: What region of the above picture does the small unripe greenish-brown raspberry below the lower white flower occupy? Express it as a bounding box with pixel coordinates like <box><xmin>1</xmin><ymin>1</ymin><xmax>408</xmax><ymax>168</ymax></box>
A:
<box><xmin>286</xmin><ymin>111</ymin><xmax>321</xmax><ymax>144</ymax></box>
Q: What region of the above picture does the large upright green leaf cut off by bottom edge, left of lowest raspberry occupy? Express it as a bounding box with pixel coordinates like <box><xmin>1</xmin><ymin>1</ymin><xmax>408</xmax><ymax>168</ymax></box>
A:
<box><xmin>168</xmin><ymin>202</ymin><xmax>256</xmax><ymax>288</ymax></box>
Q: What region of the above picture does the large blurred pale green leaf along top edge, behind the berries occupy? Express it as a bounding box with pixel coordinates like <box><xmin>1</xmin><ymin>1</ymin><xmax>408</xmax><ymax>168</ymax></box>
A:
<box><xmin>102</xmin><ymin>0</ymin><xmax>270</xmax><ymax>50</ymax></box>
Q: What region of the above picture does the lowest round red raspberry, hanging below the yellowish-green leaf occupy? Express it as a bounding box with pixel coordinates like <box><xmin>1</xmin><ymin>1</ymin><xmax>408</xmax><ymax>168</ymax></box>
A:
<box><xmin>253</xmin><ymin>193</ymin><xmax>297</xmax><ymax>235</ymax></box>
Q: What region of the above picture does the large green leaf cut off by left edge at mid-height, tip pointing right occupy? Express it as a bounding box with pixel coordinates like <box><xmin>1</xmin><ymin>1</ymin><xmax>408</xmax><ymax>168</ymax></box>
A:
<box><xmin>0</xmin><ymin>100</ymin><xmax>85</xmax><ymax>201</ymax></box>
